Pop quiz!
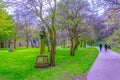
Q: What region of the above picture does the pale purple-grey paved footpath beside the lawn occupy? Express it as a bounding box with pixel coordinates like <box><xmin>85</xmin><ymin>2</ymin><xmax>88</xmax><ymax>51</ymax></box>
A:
<box><xmin>87</xmin><ymin>50</ymin><xmax>120</xmax><ymax>80</ymax></box>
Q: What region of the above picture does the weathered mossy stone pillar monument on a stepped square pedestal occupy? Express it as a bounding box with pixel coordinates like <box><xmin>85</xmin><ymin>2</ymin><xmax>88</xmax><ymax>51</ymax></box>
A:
<box><xmin>35</xmin><ymin>26</ymin><xmax>49</xmax><ymax>68</ymax></box>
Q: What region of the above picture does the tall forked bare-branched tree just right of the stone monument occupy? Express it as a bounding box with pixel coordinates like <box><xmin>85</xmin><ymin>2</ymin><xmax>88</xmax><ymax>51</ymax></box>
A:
<box><xmin>28</xmin><ymin>0</ymin><xmax>57</xmax><ymax>66</ymax></box>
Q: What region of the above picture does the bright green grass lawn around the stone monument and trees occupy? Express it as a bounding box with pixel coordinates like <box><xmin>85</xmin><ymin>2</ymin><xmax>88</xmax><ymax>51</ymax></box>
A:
<box><xmin>0</xmin><ymin>48</ymin><xmax>98</xmax><ymax>80</ymax></box>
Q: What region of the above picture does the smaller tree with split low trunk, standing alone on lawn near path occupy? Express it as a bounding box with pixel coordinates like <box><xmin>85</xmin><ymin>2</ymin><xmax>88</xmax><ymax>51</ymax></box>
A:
<box><xmin>58</xmin><ymin>0</ymin><xmax>89</xmax><ymax>56</ymax></box>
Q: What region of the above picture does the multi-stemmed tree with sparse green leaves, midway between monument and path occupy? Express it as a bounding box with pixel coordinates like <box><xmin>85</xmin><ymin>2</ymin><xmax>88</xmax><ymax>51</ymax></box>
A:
<box><xmin>57</xmin><ymin>0</ymin><xmax>94</xmax><ymax>56</ymax></box>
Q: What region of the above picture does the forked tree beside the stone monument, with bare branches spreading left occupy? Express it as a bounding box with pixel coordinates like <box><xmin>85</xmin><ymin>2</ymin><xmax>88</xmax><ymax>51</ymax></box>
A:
<box><xmin>6</xmin><ymin>0</ymin><xmax>57</xmax><ymax>66</ymax></box>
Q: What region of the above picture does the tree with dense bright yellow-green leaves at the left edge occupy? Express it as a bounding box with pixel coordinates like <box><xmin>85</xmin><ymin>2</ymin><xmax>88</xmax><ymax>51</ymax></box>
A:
<box><xmin>0</xmin><ymin>2</ymin><xmax>14</xmax><ymax>47</ymax></box>
